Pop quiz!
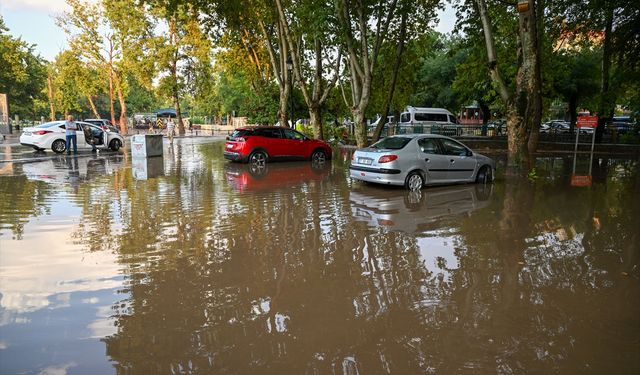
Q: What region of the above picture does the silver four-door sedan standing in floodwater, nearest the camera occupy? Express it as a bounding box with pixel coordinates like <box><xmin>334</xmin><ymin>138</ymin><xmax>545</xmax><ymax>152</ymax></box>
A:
<box><xmin>349</xmin><ymin>134</ymin><xmax>496</xmax><ymax>190</ymax></box>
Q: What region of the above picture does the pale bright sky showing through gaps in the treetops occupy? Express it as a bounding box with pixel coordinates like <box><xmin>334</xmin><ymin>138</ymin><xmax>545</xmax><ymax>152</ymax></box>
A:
<box><xmin>0</xmin><ymin>0</ymin><xmax>456</xmax><ymax>61</ymax></box>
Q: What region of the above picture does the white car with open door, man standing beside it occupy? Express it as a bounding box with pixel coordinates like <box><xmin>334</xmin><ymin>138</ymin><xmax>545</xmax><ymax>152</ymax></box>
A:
<box><xmin>20</xmin><ymin>121</ymin><xmax>124</xmax><ymax>154</ymax></box>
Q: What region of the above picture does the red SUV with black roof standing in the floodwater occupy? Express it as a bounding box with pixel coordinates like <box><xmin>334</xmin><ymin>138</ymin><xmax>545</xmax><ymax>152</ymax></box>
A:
<box><xmin>224</xmin><ymin>126</ymin><xmax>331</xmax><ymax>164</ymax></box>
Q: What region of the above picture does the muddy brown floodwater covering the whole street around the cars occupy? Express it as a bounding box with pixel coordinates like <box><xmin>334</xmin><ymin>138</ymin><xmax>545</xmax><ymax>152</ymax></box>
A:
<box><xmin>0</xmin><ymin>139</ymin><xmax>640</xmax><ymax>375</ymax></box>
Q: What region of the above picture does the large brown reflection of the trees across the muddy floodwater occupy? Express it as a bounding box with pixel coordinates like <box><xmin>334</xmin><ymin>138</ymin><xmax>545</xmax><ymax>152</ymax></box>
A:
<box><xmin>67</xmin><ymin>145</ymin><xmax>639</xmax><ymax>373</ymax></box>
